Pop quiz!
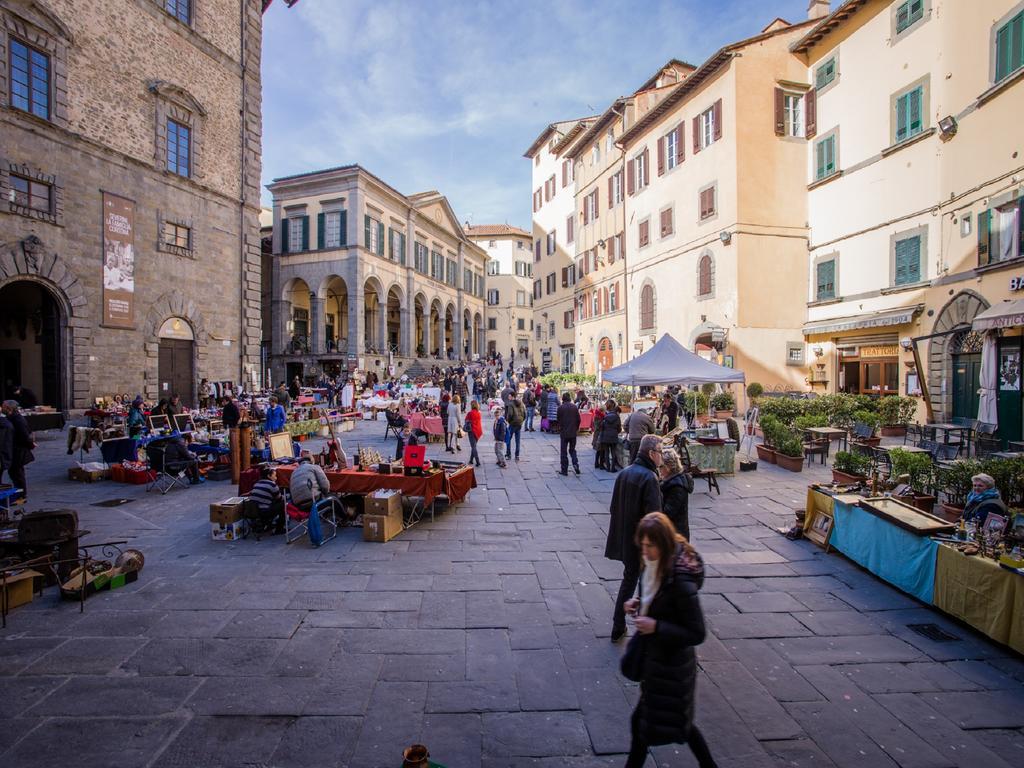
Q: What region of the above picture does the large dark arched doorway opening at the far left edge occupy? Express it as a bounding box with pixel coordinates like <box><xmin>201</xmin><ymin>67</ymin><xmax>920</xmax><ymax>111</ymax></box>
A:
<box><xmin>0</xmin><ymin>280</ymin><xmax>67</xmax><ymax>410</ymax></box>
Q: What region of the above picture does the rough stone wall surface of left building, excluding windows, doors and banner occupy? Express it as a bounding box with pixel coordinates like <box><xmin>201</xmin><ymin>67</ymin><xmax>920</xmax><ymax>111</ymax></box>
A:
<box><xmin>0</xmin><ymin>0</ymin><xmax>262</xmax><ymax>408</ymax></box>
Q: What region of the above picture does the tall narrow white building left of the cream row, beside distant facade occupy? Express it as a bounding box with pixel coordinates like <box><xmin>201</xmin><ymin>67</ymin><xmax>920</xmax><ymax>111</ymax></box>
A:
<box><xmin>523</xmin><ymin>118</ymin><xmax>593</xmax><ymax>372</ymax></box>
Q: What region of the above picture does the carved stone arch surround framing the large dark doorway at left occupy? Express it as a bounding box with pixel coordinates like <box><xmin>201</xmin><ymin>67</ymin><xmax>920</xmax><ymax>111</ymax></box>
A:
<box><xmin>0</xmin><ymin>234</ymin><xmax>87</xmax><ymax>409</ymax></box>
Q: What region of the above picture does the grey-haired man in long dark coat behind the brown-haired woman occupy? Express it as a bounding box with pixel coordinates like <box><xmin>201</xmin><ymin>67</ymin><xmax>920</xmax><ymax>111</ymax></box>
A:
<box><xmin>604</xmin><ymin>435</ymin><xmax>662</xmax><ymax>643</ymax></box>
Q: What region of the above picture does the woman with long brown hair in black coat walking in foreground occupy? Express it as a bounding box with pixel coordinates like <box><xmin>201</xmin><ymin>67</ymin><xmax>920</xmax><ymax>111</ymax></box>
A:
<box><xmin>625</xmin><ymin>512</ymin><xmax>715</xmax><ymax>768</ymax></box>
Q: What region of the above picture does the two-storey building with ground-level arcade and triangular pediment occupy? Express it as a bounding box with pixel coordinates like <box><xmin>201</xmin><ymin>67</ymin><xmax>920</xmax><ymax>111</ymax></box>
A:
<box><xmin>267</xmin><ymin>165</ymin><xmax>487</xmax><ymax>382</ymax></box>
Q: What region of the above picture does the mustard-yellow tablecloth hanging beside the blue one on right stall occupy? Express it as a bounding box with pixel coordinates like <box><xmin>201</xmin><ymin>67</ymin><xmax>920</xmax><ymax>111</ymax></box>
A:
<box><xmin>934</xmin><ymin>546</ymin><xmax>1024</xmax><ymax>653</ymax></box>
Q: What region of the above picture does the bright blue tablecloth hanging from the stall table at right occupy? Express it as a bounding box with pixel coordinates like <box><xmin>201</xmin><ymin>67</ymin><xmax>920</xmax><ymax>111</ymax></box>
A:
<box><xmin>828</xmin><ymin>499</ymin><xmax>939</xmax><ymax>605</ymax></box>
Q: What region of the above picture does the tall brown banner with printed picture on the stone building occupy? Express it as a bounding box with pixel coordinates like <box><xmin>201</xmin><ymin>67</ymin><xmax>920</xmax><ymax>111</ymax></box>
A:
<box><xmin>103</xmin><ymin>193</ymin><xmax>135</xmax><ymax>328</ymax></box>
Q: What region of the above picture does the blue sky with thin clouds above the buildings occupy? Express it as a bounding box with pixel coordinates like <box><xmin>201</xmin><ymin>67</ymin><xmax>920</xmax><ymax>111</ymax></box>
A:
<box><xmin>262</xmin><ymin>0</ymin><xmax>815</xmax><ymax>230</ymax></box>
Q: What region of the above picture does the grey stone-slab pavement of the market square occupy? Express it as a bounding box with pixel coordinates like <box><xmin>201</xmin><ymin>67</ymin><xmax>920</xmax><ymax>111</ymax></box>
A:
<box><xmin>0</xmin><ymin>415</ymin><xmax>1024</xmax><ymax>768</ymax></box>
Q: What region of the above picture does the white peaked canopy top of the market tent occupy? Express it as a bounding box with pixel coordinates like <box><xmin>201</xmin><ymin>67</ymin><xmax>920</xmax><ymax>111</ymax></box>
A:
<box><xmin>602</xmin><ymin>334</ymin><xmax>745</xmax><ymax>387</ymax></box>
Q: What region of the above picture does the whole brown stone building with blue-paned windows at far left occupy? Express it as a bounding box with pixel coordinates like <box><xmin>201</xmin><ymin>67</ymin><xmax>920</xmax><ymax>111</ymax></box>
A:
<box><xmin>0</xmin><ymin>0</ymin><xmax>262</xmax><ymax>410</ymax></box>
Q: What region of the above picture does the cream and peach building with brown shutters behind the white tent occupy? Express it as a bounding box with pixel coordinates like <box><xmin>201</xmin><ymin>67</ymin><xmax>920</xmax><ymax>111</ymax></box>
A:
<box><xmin>618</xmin><ymin>19</ymin><xmax>811</xmax><ymax>389</ymax></box>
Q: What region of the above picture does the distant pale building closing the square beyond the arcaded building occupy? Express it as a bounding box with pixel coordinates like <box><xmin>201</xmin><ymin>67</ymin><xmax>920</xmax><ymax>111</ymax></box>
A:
<box><xmin>466</xmin><ymin>224</ymin><xmax>534</xmax><ymax>366</ymax></box>
